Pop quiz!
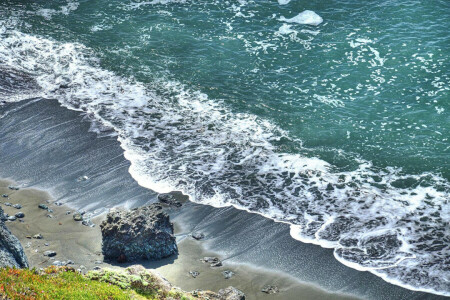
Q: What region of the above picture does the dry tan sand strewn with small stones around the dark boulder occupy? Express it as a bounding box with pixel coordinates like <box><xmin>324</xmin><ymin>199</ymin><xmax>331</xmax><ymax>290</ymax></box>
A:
<box><xmin>0</xmin><ymin>179</ymin><xmax>359</xmax><ymax>300</ymax></box>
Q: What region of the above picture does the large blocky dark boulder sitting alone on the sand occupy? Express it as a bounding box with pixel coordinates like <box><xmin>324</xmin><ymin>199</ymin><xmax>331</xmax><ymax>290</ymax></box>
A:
<box><xmin>100</xmin><ymin>204</ymin><xmax>178</xmax><ymax>262</ymax></box>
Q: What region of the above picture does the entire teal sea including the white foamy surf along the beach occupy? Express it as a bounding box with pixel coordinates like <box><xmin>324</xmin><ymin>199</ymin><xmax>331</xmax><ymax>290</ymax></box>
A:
<box><xmin>0</xmin><ymin>0</ymin><xmax>450</xmax><ymax>296</ymax></box>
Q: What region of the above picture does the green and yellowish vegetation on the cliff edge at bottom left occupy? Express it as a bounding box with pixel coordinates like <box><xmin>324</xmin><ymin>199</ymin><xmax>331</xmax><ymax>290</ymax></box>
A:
<box><xmin>0</xmin><ymin>266</ymin><xmax>193</xmax><ymax>300</ymax></box>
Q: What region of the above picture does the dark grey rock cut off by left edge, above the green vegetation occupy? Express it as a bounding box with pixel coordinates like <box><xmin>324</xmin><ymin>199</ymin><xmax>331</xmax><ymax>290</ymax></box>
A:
<box><xmin>0</xmin><ymin>207</ymin><xmax>28</xmax><ymax>268</ymax></box>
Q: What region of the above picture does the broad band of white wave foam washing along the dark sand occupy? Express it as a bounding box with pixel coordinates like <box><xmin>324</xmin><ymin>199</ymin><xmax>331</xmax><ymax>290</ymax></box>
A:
<box><xmin>0</xmin><ymin>24</ymin><xmax>450</xmax><ymax>295</ymax></box>
